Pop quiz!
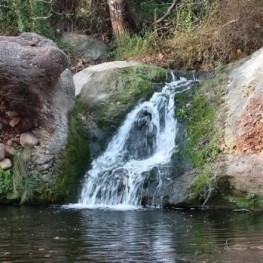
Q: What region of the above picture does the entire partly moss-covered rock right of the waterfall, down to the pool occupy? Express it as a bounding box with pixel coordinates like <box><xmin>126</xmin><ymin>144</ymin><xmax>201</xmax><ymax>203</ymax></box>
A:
<box><xmin>166</xmin><ymin>49</ymin><xmax>263</xmax><ymax>210</ymax></box>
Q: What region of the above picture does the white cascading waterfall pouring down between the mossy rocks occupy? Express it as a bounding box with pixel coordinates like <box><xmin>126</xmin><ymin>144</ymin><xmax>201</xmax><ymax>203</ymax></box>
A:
<box><xmin>72</xmin><ymin>76</ymin><xmax>194</xmax><ymax>208</ymax></box>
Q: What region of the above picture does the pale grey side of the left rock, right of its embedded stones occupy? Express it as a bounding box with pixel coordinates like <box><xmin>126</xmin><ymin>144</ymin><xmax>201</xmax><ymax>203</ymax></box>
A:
<box><xmin>34</xmin><ymin>69</ymin><xmax>75</xmax><ymax>172</ymax></box>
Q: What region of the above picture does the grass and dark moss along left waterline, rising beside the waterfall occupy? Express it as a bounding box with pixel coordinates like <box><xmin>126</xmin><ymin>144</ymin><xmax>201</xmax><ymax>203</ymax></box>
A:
<box><xmin>0</xmin><ymin>103</ymin><xmax>90</xmax><ymax>204</ymax></box>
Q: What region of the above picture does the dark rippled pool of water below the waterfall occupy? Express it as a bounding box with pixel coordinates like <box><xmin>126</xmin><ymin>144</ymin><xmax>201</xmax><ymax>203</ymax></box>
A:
<box><xmin>0</xmin><ymin>206</ymin><xmax>263</xmax><ymax>263</ymax></box>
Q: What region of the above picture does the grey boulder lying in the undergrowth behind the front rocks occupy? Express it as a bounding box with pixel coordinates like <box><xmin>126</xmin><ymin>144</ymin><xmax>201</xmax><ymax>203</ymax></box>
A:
<box><xmin>61</xmin><ymin>33</ymin><xmax>109</xmax><ymax>61</ymax></box>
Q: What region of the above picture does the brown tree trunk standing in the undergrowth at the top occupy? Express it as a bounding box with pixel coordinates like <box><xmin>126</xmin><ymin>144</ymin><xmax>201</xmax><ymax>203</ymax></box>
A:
<box><xmin>108</xmin><ymin>0</ymin><xmax>127</xmax><ymax>36</ymax></box>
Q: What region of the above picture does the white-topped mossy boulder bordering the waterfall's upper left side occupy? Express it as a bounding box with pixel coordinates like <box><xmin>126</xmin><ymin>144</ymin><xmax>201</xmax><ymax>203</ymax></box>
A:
<box><xmin>73</xmin><ymin>61</ymin><xmax>166</xmax><ymax>159</ymax></box>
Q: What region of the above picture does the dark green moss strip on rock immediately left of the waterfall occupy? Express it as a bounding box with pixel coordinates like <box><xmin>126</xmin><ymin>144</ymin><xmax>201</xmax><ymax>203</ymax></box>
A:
<box><xmin>34</xmin><ymin>102</ymin><xmax>90</xmax><ymax>202</ymax></box>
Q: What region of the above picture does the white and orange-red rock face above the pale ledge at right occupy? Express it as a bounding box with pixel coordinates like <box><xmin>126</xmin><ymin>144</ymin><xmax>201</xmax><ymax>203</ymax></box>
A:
<box><xmin>224</xmin><ymin>49</ymin><xmax>263</xmax><ymax>154</ymax></box>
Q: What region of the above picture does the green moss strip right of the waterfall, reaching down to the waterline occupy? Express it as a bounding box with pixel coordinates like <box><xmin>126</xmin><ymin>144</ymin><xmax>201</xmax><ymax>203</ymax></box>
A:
<box><xmin>173</xmin><ymin>65</ymin><xmax>232</xmax><ymax>205</ymax></box>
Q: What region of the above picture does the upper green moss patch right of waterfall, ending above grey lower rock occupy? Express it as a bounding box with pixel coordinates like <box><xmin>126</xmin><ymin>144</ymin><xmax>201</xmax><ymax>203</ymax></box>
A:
<box><xmin>176</xmin><ymin>67</ymin><xmax>231</xmax><ymax>171</ymax></box>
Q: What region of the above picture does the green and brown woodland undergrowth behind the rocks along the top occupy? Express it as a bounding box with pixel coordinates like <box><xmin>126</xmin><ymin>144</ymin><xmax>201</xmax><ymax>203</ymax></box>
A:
<box><xmin>0</xmin><ymin>0</ymin><xmax>263</xmax><ymax>70</ymax></box>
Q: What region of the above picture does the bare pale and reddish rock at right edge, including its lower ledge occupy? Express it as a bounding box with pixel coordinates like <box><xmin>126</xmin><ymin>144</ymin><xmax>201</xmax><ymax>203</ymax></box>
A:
<box><xmin>224</xmin><ymin>48</ymin><xmax>263</xmax><ymax>200</ymax></box>
